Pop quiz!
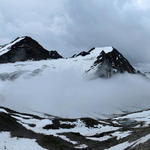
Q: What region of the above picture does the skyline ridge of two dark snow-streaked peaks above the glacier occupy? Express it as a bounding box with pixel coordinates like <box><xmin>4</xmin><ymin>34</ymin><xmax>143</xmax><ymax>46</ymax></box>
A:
<box><xmin>0</xmin><ymin>36</ymin><xmax>144</xmax><ymax>78</ymax></box>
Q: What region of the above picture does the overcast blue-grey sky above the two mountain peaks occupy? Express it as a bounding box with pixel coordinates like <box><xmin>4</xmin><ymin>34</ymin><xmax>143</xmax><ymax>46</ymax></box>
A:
<box><xmin>0</xmin><ymin>0</ymin><xmax>150</xmax><ymax>62</ymax></box>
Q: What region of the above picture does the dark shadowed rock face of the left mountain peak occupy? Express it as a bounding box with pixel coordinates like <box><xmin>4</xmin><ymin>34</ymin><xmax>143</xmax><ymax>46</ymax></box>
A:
<box><xmin>0</xmin><ymin>37</ymin><xmax>62</xmax><ymax>63</ymax></box>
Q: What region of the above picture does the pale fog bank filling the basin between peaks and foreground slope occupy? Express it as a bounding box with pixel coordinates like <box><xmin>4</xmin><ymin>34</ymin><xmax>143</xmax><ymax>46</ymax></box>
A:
<box><xmin>0</xmin><ymin>69</ymin><xmax>150</xmax><ymax>118</ymax></box>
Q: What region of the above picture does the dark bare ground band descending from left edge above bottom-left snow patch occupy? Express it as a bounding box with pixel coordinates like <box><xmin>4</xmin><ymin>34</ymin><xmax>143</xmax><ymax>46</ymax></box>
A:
<box><xmin>0</xmin><ymin>108</ymin><xmax>74</xmax><ymax>150</ymax></box>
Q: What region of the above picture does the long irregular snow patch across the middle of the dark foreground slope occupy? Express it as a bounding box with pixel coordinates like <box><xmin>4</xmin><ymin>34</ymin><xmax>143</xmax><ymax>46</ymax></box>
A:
<box><xmin>13</xmin><ymin>113</ymin><xmax>118</xmax><ymax>136</ymax></box>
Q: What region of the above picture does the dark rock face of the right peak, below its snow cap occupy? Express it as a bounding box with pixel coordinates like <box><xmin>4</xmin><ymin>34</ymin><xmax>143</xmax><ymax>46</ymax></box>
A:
<box><xmin>90</xmin><ymin>48</ymin><xmax>137</xmax><ymax>78</ymax></box>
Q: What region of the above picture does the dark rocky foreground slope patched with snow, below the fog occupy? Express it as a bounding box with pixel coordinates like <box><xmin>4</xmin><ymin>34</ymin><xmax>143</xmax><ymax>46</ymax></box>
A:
<box><xmin>0</xmin><ymin>107</ymin><xmax>150</xmax><ymax>150</ymax></box>
